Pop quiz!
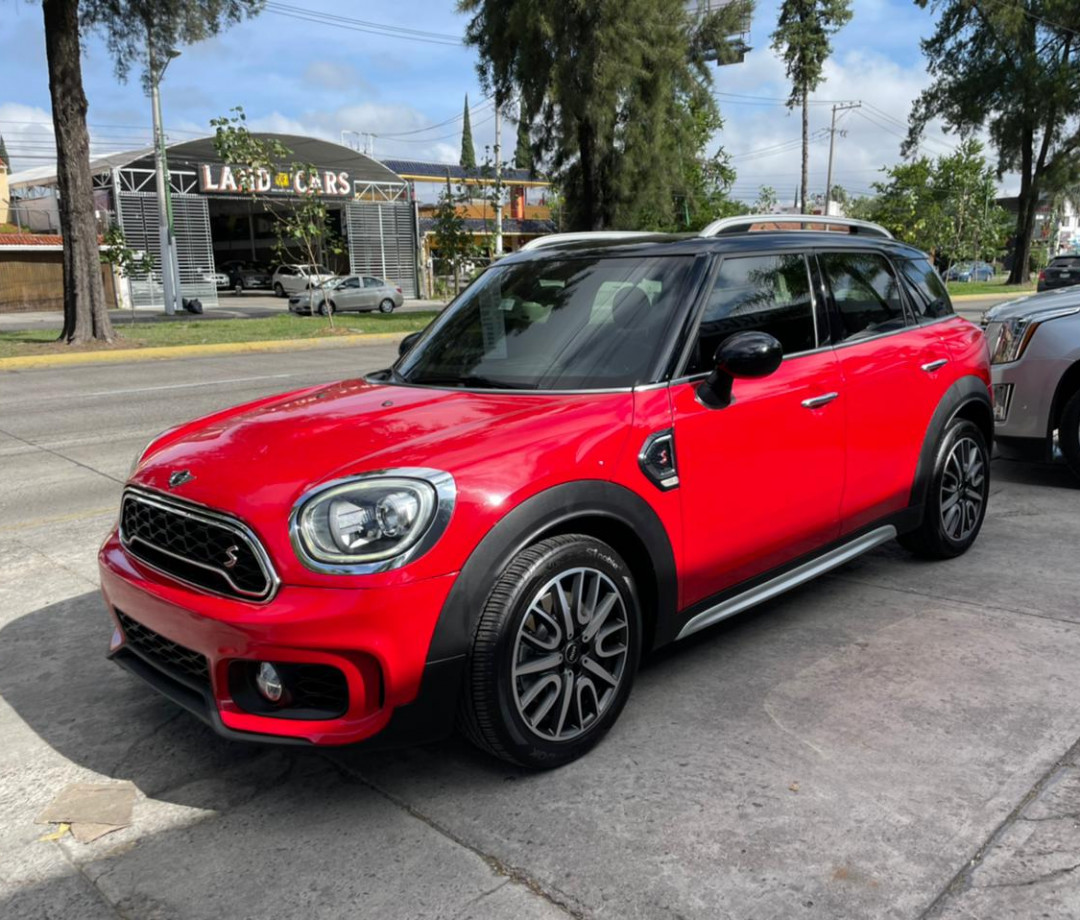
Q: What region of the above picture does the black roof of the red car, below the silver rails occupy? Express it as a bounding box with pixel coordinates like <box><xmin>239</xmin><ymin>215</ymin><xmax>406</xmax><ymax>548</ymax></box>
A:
<box><xmin>499</xmin><ymin>230</ymin><xmax>927</xmax><ymax>265</ymax></box>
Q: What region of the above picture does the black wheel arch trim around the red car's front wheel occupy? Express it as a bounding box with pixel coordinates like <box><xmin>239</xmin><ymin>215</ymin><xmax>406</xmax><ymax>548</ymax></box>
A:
<box><xmin>428</xmin><ymin>479</ymin><xmax>678</xmax><ymax>664</ymax></box>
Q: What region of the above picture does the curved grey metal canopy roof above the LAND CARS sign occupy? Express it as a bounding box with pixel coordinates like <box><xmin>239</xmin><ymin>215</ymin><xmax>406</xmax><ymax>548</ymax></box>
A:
<box><xmin>10</xmin><ymin>132</ymin><xmax>403</xmax><ymax>189</ymax></box>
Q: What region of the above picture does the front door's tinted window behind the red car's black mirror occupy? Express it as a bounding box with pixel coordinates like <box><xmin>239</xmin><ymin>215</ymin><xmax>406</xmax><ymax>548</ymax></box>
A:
<box><xmin>688</xmin><ymin>255</ymin><xmax>818</xmax><ymax>374</ymax></box>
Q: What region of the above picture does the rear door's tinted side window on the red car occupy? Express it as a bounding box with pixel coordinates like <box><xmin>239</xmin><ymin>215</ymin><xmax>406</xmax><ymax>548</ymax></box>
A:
<box><xmin>821</xmin><ymin>253</ymin><xmax>907</xmax><ymax>341</ymax></box>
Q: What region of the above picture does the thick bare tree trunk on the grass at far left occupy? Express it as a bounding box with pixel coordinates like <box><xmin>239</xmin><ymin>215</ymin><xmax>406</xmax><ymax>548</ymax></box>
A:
<box><xmin>42</xmin><ymin>0</ymin><xmax>113</xmax><ymax>344</ymax></box>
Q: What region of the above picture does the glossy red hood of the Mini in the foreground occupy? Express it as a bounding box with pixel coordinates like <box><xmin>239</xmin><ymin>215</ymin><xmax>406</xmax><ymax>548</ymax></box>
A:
<box><xmin>132</xmin><ymin>380</ymin><xmax>633</xmax><ymax>583</ymax></box>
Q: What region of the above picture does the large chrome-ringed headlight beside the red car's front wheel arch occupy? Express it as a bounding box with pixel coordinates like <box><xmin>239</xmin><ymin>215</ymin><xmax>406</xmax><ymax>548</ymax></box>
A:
<box><xmin>291</xmin><ymin>469</ymin><xmax>455</xmax><ymax>573</ymax></box>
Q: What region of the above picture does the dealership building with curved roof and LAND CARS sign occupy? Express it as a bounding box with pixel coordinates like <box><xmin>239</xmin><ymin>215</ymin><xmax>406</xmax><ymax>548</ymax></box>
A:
<box><xmin>10</xmin><ymin>134</ymin><xmax>420</xmax><ymax>306</ymax></box>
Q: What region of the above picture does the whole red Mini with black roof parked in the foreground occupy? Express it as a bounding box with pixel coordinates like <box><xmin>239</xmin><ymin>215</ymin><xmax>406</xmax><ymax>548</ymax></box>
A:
<box><xmin>100</xmin><ymin>218</ymin><xmax>994</xmax><ymax>768</ymax></box>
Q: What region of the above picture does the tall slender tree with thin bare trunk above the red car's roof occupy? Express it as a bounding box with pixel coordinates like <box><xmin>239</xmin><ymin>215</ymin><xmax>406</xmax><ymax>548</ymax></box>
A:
<box><xmin>772</xmin><ymin>0</ymin><xmax>851</xmax><ymax>214</ymax></box>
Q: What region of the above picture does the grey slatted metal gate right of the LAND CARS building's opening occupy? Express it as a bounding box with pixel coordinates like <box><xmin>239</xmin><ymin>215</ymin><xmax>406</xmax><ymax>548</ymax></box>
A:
<box><xmin>346</xmin><ymin>201</ymin><xmax>417</xmax><ymax>297</ymax></box>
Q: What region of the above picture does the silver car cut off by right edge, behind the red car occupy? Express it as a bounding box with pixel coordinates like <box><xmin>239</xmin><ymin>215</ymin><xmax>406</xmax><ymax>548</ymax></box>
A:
<box><xmin>983</xmin><ymin>287</ymin><xmax>1080</xmax><ymax>477</ymax></box>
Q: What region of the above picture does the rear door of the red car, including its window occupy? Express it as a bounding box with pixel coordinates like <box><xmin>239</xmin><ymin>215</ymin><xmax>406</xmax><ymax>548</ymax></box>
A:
<box><xmin>818</xmin><ymin>251</ymin><xmax>949</xmax><ymax>533</ymax></box>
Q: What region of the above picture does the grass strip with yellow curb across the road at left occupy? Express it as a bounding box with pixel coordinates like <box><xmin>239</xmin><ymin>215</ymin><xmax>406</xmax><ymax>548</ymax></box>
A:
<box><xmin>0</xmin><ymin>310</ymin><xmax>438</xmax><ymax>357</ymax></box>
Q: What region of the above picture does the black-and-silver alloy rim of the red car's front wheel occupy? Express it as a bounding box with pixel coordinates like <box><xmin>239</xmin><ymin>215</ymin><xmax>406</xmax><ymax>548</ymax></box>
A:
<box><xmin>511</xmin><ymin>568</ymin><xmax>630</xmax><ymax>742</ymax></box>
